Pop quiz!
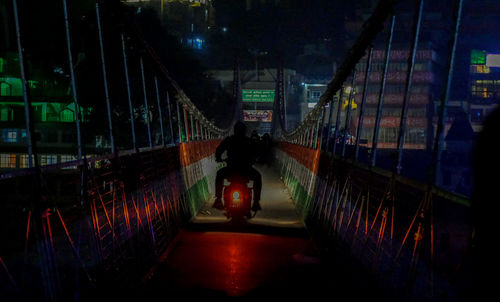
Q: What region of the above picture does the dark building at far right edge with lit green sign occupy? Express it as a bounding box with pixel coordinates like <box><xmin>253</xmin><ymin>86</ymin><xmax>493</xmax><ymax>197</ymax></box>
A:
<box><xmin>452</xmin><ymin>0</ymin><xmax>500</xmax><ymax>133</ymax></box>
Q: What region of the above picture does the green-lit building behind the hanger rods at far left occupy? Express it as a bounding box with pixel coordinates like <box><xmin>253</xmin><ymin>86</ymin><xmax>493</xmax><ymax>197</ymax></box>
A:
<box><xmin>0</xmin><ymin>52</ymin><xmax>87</xmax><ymax>170</ymax></box>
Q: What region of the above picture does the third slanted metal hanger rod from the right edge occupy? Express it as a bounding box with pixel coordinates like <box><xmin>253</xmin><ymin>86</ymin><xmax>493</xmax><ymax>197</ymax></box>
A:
<box><xmin>371</xmin><ymin>16</ymin><xmax>396</xmax><ymax>167</ymax></box>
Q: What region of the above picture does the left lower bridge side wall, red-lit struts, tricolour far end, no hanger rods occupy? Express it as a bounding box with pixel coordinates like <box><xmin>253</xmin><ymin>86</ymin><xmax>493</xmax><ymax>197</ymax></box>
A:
<box><xmin>0</xmin><ymin>140</ymin><xmax>219</xmax><ymax>301</ymax></box>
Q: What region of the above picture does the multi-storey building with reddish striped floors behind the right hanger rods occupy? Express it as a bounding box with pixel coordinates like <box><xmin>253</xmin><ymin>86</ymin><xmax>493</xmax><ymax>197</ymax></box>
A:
<box><xmin>353</xmin><ymin>49</ymin><xmax>442</xmax><ymax>150</ymax></box>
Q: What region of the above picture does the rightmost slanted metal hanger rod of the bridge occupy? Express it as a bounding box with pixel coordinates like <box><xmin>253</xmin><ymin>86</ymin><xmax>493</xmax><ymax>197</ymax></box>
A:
<box><xmin>431</xmin><ymin>0</ymin><xmax>463</xmax><ymax>185</ymax></box>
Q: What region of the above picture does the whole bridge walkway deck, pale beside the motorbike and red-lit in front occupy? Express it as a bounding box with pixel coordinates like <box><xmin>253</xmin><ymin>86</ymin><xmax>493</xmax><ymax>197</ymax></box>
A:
<box><xmin>132</xmin><ymin>167</ymin><xmax>387</xmax><ymax>301</ymax></box>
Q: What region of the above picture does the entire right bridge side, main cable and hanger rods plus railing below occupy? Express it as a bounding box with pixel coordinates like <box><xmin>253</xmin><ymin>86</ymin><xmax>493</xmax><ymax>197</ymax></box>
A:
<box><xmin>274</xmin><ymin>0</ymin><xmax>472</xmax><ymax>301</ymax></box>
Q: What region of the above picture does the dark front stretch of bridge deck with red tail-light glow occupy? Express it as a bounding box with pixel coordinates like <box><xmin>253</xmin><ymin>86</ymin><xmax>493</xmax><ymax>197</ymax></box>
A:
<box><xmin>110</xmin><ymin>222</ymin><xmax>391</xmax><ymax>302</ymax></box>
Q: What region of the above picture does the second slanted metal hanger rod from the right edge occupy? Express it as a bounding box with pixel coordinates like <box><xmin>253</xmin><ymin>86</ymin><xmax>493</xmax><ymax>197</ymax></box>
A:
<box><xmin>395</xmin><ymin>0</ymin><xmax>424</xmax><ymax>174</ymax></box>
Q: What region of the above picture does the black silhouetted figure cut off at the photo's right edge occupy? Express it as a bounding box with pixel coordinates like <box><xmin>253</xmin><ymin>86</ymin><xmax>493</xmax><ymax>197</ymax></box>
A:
<box><xmin>465</xmin><ymin>107</ymin><xmax>500</xmax><ymax>301</ymax></box>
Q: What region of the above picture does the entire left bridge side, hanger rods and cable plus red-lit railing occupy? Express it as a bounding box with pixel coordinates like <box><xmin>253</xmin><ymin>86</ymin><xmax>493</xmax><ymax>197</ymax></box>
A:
<box><xmin>0</xmin><ymin>0</ymin><xmax>238</xmax><ymax>301</ymax></box>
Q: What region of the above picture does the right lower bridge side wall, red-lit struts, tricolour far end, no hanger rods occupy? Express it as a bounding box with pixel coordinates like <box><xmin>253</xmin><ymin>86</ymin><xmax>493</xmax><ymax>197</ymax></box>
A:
<box><xmin>276</xmin><ymin>142</ymin><xmax>472</xmax><ymax>301</ymax></box>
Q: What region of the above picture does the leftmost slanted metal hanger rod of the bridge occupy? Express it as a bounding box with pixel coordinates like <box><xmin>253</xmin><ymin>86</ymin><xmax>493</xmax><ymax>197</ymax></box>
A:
<box><xmin>12</xmin><ymin>0</ymin><xmax>38</xmax><ymax>168</ymax></box>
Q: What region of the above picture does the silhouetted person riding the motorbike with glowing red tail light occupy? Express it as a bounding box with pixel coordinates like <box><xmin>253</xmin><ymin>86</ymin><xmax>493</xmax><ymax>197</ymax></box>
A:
<box><xmin>212</xmin><ymin>121</ymin><xmax>262</xmax><ymax>211</ymax></box>
